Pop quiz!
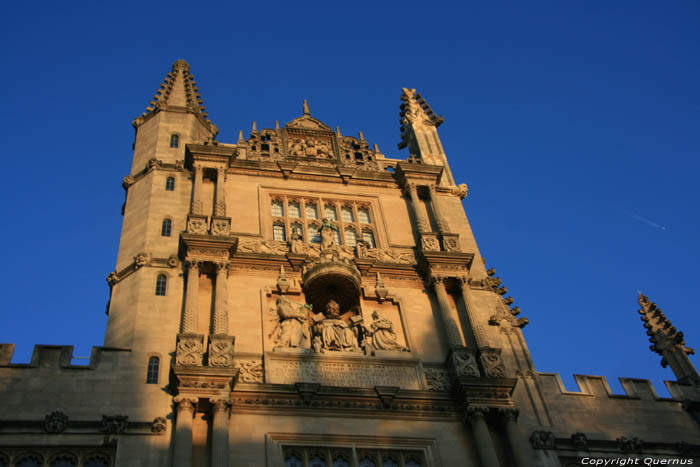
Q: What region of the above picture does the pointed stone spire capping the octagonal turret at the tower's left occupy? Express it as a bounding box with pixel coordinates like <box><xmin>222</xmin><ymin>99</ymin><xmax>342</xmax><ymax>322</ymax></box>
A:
<box><xmin>132</xmin><ymin>60</ymin><xmax>218</xmax><ymax>136</ymax></box>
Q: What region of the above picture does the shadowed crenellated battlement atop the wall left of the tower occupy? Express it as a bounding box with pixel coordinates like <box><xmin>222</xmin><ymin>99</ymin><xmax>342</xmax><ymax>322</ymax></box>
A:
<box><xmin>0</xmin><ymin>344</ymin><xmax>131</xmax><ymax>370</ymax></box>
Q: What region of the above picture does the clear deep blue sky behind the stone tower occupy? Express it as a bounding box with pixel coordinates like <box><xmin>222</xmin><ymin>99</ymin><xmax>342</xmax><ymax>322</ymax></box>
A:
<box><xmin>0</xmin><ymin>1</ymin><xmax>700</xmax><ymax>394</ymax></box>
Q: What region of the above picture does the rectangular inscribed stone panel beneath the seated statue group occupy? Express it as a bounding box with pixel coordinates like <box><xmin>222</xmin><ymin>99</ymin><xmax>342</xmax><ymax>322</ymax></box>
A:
<box><xmin>265</xmin><ymin>353</ymin><xmax>423</xmax><ymax>389</ymax></box>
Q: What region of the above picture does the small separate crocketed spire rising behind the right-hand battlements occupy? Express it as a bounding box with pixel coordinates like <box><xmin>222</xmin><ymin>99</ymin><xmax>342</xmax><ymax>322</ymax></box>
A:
<box><xmin>637</xmin><ymin>293</ymin><xmax>700</xmax><ymax>384</ymax></box>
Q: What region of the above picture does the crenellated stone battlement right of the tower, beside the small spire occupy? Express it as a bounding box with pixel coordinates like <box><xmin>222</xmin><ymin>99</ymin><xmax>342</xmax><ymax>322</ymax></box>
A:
<box><xmin>538</xmin><ymin>373</ymin><xmax>687</xmax><ymax>401</ymax></box>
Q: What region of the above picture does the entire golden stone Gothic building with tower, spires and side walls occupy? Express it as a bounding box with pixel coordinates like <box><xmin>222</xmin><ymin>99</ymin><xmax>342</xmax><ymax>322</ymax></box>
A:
<box><xmin>0</xmin><ymin>61</ymin><xmax>700</xmax><ymax>467</ymax></box>
